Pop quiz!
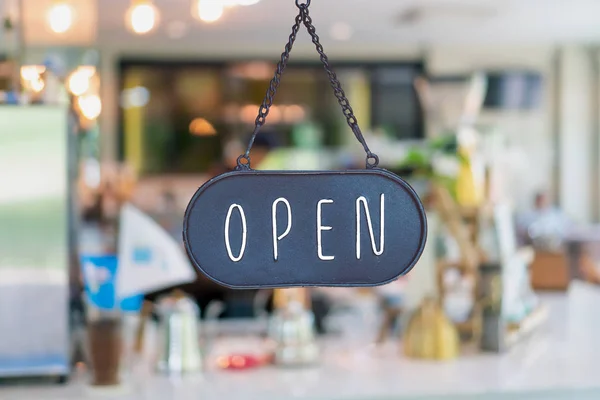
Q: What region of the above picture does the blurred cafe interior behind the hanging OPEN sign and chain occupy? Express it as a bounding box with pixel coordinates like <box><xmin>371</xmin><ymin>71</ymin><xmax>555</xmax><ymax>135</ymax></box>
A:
<box><xmin>0</xmin><ymin>0</ymin><xmax>600</xmax><ymax>400</ymax></box>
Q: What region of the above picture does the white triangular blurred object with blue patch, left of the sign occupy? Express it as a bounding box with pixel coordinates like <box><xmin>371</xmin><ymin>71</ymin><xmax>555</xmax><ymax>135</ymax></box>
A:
<box><xmin>116</xmin><ymin>204</ymin><xmax>196</xmax><ymax>298</ymax></box>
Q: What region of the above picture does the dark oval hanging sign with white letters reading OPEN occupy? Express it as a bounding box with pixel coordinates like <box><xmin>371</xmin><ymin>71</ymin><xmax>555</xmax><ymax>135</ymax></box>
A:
<box><xmin>183</xmin><ymin>169</ymin><xmax>427</xmax><ymax>289</ymax></box>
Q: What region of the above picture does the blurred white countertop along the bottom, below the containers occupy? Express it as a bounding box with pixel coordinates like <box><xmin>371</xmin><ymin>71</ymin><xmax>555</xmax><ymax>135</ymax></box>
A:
<box><xmin>0</xmin><ymin>285</ymin><xmax>600</xmax><ymax>400</ymax></box>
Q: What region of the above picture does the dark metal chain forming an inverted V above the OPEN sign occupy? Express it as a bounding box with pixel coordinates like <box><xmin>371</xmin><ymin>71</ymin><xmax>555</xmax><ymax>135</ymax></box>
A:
<box><xmin>237</xmin><ymin>0</ymin><xmax>379</xmax><ymax>169</ymax></box>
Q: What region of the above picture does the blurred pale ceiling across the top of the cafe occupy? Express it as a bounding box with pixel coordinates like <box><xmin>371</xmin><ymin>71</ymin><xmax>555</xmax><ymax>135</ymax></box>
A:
<box><xmin>0</xmin><ymin>0</ymin><xmax>600</xmax><ymax>52</ymax></box>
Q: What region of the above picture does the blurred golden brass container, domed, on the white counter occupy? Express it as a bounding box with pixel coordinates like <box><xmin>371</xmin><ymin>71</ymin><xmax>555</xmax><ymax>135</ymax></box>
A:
<box><xmin>403</xmin><ymin>299</ymin><xmax>460</xmax><ymax>360</ymax></box>
